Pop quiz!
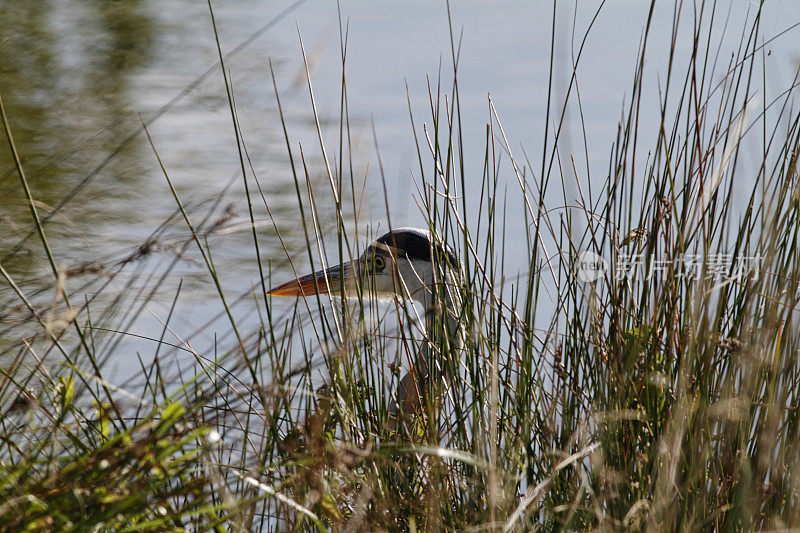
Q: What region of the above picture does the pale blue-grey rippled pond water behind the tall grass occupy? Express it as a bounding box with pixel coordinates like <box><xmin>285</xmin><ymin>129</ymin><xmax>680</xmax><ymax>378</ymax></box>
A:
<box><xmin>0</xmin><ymin>0</ymin><xmax>800</xmax><ymax>380</ymax></box>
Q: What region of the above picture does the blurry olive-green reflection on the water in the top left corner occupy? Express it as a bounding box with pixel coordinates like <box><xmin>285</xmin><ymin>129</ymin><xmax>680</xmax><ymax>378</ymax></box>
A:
<box><xmin>0</xmin><ymin>0</ymin><xmax>154</xmax><ymax>195</ymax></box>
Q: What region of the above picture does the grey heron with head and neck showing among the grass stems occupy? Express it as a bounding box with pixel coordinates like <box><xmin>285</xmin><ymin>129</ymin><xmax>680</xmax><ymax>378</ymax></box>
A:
<box><xmin>268</xmin><ymin>228</ymin><xmax>462</xmax><ymax>430</ymax></box>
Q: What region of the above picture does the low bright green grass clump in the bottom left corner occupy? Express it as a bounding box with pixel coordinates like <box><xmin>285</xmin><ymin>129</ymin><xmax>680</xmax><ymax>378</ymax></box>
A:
<box><xmin>0</xmin><ymin>392</ymin><xmax>223</xmax><ymax>531</ymax></box>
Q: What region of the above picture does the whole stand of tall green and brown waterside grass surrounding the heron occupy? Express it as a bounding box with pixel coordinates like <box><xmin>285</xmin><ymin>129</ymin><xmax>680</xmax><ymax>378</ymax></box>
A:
<box><xmin>0</xmin><ymin>3</ymin><xmax>800</xmax><ymax>531</ymax></box>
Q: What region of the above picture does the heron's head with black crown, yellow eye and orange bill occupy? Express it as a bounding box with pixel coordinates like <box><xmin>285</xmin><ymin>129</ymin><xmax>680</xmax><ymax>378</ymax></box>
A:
<box><xmin>268</xmin><ymin>228</ymin><xmax>457</xmax><ymax>301</ymax></box>
